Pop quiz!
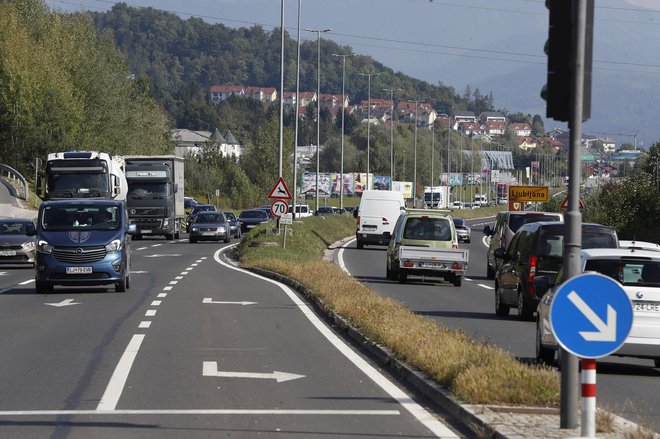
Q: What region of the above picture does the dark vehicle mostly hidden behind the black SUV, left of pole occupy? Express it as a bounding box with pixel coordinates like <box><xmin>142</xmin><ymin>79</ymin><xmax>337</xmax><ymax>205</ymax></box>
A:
<box><xmin>484</xmin><ymin>211</ymin><xmax>564</xmax><ymax>279</ymax></box>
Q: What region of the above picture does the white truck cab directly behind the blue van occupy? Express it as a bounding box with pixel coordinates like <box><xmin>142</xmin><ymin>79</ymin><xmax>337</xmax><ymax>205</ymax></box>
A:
<box><xmin>36</xmin><ymin>151</ymin><xmax>128</xmax><ymax>201</ymax></box>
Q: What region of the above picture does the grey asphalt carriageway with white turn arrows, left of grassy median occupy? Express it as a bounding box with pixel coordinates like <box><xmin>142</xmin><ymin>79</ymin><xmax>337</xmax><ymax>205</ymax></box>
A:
<box><xmin>0</xmin><ymin>230</ymin><xmax>464</xmax><ymax>439</ymax></box>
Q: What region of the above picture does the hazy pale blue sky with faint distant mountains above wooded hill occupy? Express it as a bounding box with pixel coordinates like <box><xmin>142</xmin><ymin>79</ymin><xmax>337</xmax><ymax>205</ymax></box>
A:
<box><xmin>46</xmin><ymin>0</ymin><xmax>660</xmax><ymax>148</ymax></box>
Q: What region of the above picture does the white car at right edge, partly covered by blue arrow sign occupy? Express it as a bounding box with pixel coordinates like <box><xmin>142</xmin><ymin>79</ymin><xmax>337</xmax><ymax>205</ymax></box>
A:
<box><xmin>535</xmin><ymin>249</ymin><xmax>660</xmax><ymax>367</ymax></box>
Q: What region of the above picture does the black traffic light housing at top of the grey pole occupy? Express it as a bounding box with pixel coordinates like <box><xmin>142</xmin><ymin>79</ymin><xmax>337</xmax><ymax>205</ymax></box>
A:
<box><xmin>541</xmin><ymin>0</ymin><xmax>594</xmax><ymax>122</ymax></box>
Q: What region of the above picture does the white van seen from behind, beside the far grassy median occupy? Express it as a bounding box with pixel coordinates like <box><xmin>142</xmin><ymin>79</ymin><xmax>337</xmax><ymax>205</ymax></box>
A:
<box><xmin>355</xmin><ymin>191</ymin><xmax>406</xmax><ymax>248</ymax></box>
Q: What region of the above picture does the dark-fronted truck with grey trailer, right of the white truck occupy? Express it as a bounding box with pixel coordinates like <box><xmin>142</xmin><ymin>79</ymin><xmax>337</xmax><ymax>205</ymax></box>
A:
<box><xmin>125</xmin><ymin>155</ymin><xmax>185</xmax><ymax>240</ymax></box>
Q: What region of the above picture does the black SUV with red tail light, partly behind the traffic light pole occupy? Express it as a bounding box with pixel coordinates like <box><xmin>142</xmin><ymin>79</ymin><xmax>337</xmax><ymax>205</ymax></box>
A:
<box><xmin>494</xmin><ymin>221</ymin><xmax>619</xmax><ymax>320</ymax></box>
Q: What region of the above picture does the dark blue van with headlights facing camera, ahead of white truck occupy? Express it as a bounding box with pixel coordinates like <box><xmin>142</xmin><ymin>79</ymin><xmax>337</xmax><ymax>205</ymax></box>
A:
<box><xmin>30</xmin><ymin>199</ymin><xmax>137</xmax><ymax>294</ymax></box>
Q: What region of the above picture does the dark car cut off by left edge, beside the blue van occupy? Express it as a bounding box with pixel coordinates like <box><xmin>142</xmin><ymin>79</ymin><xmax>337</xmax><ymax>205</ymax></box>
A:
<box><xmin>0</xmin><ymin>218</ymin><xmax>36</xmax><ymax>266</ymax></box>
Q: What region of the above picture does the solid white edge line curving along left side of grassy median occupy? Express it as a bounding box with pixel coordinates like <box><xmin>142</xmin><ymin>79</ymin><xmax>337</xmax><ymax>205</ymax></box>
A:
<box><xmin>213</xmin><ymin>246</ymin><xmax>458</xmax><ymax>438</ymax></box>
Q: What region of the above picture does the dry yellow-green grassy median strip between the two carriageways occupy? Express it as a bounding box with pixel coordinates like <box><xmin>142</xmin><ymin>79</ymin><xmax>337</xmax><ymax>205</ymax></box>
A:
<box><xmin>237</xmin><ymin>215</ymin><xmax>559</xmax><ymax>407</ymax></box>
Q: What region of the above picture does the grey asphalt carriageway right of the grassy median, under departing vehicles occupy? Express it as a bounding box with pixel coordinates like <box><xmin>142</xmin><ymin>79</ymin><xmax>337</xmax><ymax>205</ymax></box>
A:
<box><xmin>341</xmin><ymin>218</ymin><xmax>660</xmax><ymax>431</ymax></box>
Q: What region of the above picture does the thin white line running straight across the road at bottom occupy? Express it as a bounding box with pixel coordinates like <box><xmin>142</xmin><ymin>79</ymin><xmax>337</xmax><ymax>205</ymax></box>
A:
<box><xmin>0</xmin><ymin>409</ymin><xmax>401</xmax><ymax>416</ymax></box>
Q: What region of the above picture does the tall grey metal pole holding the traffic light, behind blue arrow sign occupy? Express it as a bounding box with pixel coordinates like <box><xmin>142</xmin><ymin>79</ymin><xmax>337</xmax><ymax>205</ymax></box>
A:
<box><xmin>560</xmin><ymin>0</ymin><xmax>589</xmax><ymax>429</ymax></box>
